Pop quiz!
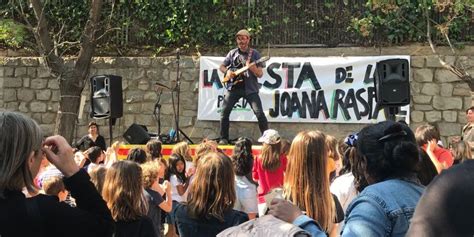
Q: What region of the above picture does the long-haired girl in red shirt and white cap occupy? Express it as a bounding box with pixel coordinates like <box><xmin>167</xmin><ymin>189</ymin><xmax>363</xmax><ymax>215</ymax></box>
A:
<box><xmin>252</xmin><ymin>129</ymin><xmax>287</xmax><ymax>216</ymax></box>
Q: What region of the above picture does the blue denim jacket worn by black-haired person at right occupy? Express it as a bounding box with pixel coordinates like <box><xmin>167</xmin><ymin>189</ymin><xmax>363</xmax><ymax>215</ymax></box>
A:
<box><xmin>343</xmin><ymin>179</ymin><xmax>424</xmax><ymax>237</ymax></box>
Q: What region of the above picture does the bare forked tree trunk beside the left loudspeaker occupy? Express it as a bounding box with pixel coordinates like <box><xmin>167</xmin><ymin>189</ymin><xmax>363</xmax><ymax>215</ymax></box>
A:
<box><xmin>19</xmin><ymin>0</ymin><xmax>103</xmax><ymax>142</ymax></box>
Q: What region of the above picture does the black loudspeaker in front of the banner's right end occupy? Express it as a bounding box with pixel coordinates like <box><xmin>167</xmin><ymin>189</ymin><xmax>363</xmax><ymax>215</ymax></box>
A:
<box><xmin>375</xmin><ymin>59</ymin><xmax>410</xmax><ymax>106</ymax></box>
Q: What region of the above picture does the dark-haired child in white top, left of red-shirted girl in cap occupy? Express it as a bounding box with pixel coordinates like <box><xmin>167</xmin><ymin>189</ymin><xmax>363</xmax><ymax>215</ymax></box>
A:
<box><xmin>231</xmin><ymin>137</ymin><xmax>258</xmax><ymax>219</ymax></box>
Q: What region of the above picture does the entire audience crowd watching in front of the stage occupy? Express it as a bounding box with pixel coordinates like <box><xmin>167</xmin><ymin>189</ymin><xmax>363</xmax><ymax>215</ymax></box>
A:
<box><xmin>0</xmin><ymin>112</ymin><xmax>474</xmax><ymax>237</ymax></box>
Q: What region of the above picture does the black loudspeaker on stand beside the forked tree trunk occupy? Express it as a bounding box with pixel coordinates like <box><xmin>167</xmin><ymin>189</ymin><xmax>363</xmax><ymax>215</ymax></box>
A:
<box><xmin>91</xmin><ymin>75</ymin><xmax>123</xmax><ymax>119</ymax></box>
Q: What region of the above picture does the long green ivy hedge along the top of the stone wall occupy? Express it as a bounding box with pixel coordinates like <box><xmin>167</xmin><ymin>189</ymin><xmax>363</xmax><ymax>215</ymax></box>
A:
<box><xmin>0</xmin><ymin>0</ymin><xmax>474</xmax><ymax>54</ymax></box>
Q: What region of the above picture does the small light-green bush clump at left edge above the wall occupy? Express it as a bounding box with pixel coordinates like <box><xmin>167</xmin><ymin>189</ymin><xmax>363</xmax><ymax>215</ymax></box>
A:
<box><xmin>0</xmin><ymin>19</ymin><xmax>28</xmax><ymax>48</ymax></box>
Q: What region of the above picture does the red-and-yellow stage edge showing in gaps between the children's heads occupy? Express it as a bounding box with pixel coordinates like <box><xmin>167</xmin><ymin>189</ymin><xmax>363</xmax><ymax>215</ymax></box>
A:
<box><xmin>118</xmin><ymin>144</ymin><xmax>262</xmax><ymax>160</ymax></box>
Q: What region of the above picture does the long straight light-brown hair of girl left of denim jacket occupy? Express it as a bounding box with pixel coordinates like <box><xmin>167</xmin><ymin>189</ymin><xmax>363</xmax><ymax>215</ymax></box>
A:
<box><xmin>283</xmin><ymin>131</ymin><xmax>337</xmax><ymax>233</ymax></box>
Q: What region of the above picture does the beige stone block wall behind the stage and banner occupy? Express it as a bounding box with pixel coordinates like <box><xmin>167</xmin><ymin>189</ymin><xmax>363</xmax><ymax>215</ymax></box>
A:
<box><xmin>0</xmin><ymin>45</ymin><xmax>474</xmax><ymax>142</ymax></box>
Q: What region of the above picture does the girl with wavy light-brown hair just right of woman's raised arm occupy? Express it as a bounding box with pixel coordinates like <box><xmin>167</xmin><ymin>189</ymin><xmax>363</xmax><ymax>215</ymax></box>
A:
<box><xmin>102</xmin><ymin>161</ymin><xmax>156</xmax><ymax>237</ymax></box>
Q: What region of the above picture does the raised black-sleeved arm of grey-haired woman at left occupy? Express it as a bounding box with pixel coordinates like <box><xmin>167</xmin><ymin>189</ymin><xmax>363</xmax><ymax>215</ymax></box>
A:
<box><xmin>40</xmin><ymin>136</ymin><xmax>114</xmax><ymax>236</ymax></box>
